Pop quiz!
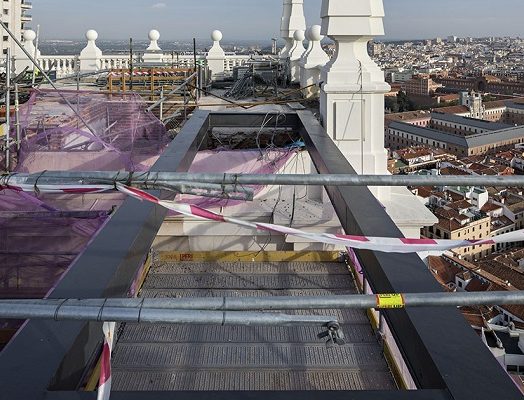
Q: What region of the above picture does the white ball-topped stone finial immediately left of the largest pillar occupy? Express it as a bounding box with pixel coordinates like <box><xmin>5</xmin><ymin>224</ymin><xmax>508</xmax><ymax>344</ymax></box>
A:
<box><xmin>300</xmin><ymin>25</ymin><xmax>329</xmax><ymax>98</ymax></box>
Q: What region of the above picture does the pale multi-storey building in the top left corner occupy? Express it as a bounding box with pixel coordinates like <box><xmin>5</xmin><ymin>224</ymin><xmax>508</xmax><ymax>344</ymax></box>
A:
<box><xmin>1</xmin><ymin>0</ymin><xmax>33</xmax><ymax>54</ymax></box>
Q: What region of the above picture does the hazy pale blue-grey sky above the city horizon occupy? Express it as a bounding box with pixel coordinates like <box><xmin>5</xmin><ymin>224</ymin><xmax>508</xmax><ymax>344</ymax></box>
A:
<box><xmin>31</xmin><ymin>0</ymin><xmax>524</xmax><ymax>39</ymax></box>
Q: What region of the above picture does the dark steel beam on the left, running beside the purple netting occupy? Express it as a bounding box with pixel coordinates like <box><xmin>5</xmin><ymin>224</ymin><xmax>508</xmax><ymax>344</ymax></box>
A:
<box><xmin>0</xmin><ymin>111</ymin><xmax>209</xmax><ymax>400</ymax></box>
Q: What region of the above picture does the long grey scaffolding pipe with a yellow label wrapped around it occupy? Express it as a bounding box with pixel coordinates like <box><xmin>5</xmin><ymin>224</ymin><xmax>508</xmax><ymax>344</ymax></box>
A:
<box><xmin>6</xmin><ymin>290</ymin><xmax>524</xmax><ymax>312</ymax></box>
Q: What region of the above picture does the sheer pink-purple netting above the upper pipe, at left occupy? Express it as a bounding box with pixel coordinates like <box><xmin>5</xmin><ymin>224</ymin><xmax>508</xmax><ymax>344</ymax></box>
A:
<box><xmin>12</xmin><ymin>90</ymin><xmax>169</xmax><ymax>172</ymax></box>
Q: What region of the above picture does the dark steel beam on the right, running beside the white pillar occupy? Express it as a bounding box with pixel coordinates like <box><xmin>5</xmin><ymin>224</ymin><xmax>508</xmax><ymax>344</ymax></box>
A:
<box><xmin>297</xmin><ymin>111</ymin><xmax>522</xmax><ymax>400</ymax></box>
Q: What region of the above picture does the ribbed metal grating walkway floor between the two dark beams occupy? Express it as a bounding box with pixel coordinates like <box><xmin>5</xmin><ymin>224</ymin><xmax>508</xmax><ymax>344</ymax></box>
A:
<box><xmin>113</xmin><ymin>262</ymin><xmax>396</xmax><ymax>391</ymax></box>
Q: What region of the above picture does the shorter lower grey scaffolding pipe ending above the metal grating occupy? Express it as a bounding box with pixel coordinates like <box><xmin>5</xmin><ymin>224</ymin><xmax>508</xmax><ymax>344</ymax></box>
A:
<box><xmin>0</xmin><ymin>300</ymin><xmax>337</xmax><ymax>327</ymax></box>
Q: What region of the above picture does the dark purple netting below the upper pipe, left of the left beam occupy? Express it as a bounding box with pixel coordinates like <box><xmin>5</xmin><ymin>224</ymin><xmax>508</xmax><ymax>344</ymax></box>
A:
<box><xmin>0</xmin><ymin>211</ymin><xmax>107</xmax><ymax>298</ymax></box>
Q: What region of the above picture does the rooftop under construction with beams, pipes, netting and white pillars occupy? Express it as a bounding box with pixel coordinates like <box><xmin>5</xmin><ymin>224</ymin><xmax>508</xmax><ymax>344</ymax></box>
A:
<box><xmin>0</xmin><ymin>0</ymin><xmax>524</xmax><ymax>400</ymax></box>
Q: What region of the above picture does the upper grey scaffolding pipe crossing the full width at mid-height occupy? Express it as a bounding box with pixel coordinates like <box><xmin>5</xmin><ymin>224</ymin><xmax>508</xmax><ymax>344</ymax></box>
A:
<box><xmin>0</xmin><ymin>171</ymin><xmax>524</xmax><ymax>187</ymax></box>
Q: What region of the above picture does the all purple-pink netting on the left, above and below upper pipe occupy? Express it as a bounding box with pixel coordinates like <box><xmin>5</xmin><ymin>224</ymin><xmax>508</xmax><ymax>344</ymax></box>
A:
<box><xmin>0</xmin><ymin>90</ymin><xmax>170</xmax><ymax>304</ymax></box>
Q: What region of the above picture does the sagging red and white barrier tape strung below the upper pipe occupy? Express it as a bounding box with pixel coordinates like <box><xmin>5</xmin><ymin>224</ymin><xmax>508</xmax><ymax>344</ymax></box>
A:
<box><xmin>117</xmin><ymin>184</ymin><xmax>524</xmax><ymax>253</ymax></box>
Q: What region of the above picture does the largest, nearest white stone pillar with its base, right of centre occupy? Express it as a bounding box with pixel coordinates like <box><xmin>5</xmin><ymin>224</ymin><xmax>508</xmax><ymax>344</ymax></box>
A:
<box><xmin>320</xmin><ymin>0</ymin><xmax>438</xmax><ymax>237</ymax></box>
